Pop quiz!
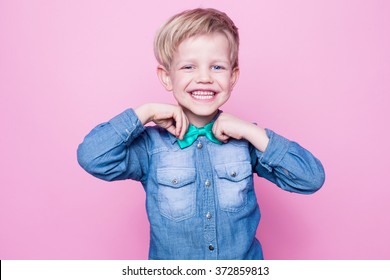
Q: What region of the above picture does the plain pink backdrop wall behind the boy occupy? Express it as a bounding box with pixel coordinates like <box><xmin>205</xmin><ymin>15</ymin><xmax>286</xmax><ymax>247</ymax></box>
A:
<box><xmin>0</xmin><ymin>0</ymin><xmax>390</xmax><ymax>259</ymax></box>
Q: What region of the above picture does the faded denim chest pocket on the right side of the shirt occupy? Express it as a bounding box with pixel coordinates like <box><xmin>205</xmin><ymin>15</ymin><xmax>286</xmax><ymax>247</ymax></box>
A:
<box><xmin>215</xmin><ymin>161</ymin><xmax>253</xmax><ymax>212</ymax></box>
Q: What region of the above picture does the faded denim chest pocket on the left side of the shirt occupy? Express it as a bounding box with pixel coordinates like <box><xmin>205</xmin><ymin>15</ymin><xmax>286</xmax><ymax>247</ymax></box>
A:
<box><xmin>157</xmin><ymin>168</ymin><xmax>196</xmax><ymax>221</ymax></box>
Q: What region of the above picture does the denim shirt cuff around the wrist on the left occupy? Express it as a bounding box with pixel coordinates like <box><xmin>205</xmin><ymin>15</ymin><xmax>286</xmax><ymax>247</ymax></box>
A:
<box><xmin>109</xmin><ymin>109</ymin><xmax>145</xmax><ymax>143</ymax></box>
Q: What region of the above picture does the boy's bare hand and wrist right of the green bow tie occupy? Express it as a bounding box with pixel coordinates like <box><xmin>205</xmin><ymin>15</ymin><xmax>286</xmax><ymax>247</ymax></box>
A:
<box><xmin>213</xmin><ymin>113</ymin><xmax>269</xmax><ymax>152</ymax></box>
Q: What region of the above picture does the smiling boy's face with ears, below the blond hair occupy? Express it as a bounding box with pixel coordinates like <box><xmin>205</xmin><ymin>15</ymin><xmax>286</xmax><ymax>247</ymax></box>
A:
<box><xmin>160</xmin><ymin>33</ymin><xmax>239</xmax><ymax>124</ymax></box>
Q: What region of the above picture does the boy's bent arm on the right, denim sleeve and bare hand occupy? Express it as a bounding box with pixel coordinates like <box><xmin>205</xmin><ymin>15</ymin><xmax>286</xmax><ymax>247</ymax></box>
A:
<box><xmin>213</xmin><ymin>113</ymin><xmax>325</xmax><ymax>194</ymax></box>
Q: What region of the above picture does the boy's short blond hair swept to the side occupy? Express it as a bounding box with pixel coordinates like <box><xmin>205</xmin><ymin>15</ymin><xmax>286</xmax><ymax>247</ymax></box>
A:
<box><xmin>154</xmin><ymin>8</ymin><xmax>239</xmax><ymax>70</ymax></box>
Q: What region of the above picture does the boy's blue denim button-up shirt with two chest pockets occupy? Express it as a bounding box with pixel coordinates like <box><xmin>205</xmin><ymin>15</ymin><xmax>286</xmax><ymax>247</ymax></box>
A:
<box><xmin>78</xmin><ymin>109</ymin><xmax>324</xmax><ymax>259</ymax></box>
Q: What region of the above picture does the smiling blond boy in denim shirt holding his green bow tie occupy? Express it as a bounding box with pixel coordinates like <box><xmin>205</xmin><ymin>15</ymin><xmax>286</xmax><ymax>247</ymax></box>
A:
<box><xmin>78</xmin><ymin>9</ymin><xmax>324</xmax><ymax>259</ymax></box>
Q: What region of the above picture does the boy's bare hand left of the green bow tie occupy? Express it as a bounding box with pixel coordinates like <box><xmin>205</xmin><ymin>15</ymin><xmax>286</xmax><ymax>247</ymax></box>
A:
<box><xmin>135</xmin><ymin>103</ymin><xmax>189</xmax><ymax>139</ymax></box>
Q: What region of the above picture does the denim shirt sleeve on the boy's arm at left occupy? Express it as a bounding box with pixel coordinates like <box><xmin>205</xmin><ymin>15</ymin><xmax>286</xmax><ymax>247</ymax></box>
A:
<box><xmin>77</xmin><ymin>109</ymin><xmax>149</xmax><ymax>181</ymax></box>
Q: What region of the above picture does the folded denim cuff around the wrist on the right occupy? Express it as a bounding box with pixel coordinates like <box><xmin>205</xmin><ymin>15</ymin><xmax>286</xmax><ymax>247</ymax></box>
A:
<box><xmin>256</xmin><ymin>128</ymin><xmax>290</xmax><ymax>172</ymax></box>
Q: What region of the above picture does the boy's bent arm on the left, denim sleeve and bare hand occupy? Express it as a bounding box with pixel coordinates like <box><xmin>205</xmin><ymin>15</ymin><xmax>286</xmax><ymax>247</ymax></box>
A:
<box><xmin>77</xmin><ymin>103</ymin><xmax>188</xmax><ymax>181</ymax></box>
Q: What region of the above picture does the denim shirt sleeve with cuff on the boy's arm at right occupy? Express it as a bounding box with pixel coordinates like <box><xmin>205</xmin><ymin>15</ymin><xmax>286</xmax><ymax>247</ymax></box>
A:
<box><xmin>251</xmin><ymin>129</ymin><xmax>325</xmax><ymax>194</ymax></box>
